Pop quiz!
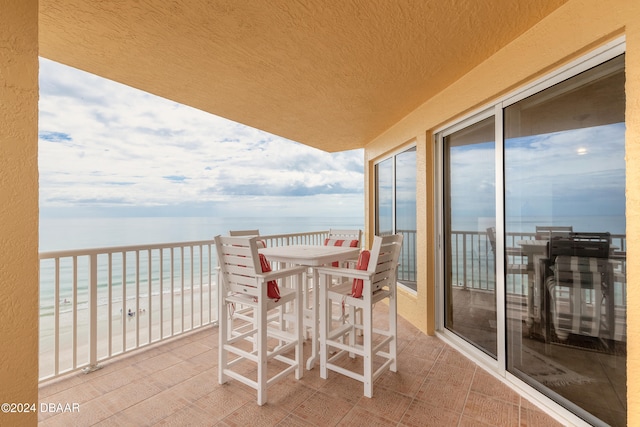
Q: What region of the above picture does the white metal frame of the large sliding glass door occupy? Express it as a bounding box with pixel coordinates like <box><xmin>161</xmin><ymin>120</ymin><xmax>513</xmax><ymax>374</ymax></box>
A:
<box><xmin>427</xmin><ymin>36</ymin><xmax>626</xmax><ymax>425</ymax></box>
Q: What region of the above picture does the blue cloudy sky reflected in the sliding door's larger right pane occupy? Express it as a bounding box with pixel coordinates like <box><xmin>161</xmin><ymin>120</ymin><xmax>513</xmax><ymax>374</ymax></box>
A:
<box><xmin>505</xmin><ymin>123</ymin><xmax>626</xmax><ymax>216</ymax></box>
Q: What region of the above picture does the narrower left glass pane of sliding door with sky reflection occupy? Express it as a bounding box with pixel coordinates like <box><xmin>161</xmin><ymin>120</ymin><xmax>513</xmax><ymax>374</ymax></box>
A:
<box><xmin>443</xmin><ymin>117</ymin><xmax>497</xmax><ymax>358</ymax></box>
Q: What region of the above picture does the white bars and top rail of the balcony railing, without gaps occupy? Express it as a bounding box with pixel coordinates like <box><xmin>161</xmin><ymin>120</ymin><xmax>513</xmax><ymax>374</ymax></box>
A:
<box><xmin>39</xmin><ymin>236</ymin><xmax>336</xmax><ymax>380</ymax></box>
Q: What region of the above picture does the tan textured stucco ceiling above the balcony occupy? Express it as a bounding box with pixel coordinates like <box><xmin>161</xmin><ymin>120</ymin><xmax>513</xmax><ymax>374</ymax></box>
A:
<box><xmin>39</xmin><ymin>0</ymin><xmax>566</xmax><ymax>151</ymax></box>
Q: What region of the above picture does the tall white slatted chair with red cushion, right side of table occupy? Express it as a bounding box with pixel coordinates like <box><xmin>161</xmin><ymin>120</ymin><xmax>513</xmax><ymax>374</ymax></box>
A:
<box><xmin>318</xmin><ymin>234</ymin><xmax>402</xmax><ymax>397</ymax></box>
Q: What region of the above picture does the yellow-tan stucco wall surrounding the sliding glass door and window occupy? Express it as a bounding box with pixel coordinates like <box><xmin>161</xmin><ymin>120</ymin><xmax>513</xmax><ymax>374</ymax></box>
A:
<box><xmin>365</xmin><ymin>0</ymin><xmax>640</xmax><ymax>425</ymax></box>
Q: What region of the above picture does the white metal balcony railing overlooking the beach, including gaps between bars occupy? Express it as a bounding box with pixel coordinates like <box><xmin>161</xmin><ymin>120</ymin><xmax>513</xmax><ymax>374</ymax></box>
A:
<box><xmin>39</xmin><ymin>231</ymin><xmax>328</xmax><ymax>380</ymax></box>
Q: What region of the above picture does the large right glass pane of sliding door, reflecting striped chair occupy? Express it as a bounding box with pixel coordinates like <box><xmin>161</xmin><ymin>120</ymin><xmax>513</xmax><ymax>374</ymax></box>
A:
<box><xmin>504</xmin><ymin>56</ymin><xmax>626</xmax><ymax>425</ymax></box>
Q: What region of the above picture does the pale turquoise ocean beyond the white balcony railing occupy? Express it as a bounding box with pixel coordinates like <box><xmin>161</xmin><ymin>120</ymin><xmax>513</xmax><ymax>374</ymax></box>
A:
<box><xmin>40</xmin><ymin>217</ymin><xmax>364</xmax><ymax>317</ymax></box>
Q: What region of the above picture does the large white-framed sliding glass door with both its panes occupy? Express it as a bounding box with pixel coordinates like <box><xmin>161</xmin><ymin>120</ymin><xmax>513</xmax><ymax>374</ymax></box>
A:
<box><xmin>436</xmin><ymin>45</ymin><xmax>627</xmax><ymax>425</ymax></box>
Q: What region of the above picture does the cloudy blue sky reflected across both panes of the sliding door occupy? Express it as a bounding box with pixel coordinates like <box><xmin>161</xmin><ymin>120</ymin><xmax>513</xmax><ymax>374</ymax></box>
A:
<box><xmin>450</xmin><ymin>123</ymin><xmax>625</xmax><ymax>216</ymax></box>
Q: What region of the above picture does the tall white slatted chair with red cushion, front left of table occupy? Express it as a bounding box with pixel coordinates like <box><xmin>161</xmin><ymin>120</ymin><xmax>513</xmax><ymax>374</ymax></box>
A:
<box><xmin>215</xmin><ymin>236</ymin><xmax>305</xmax><ymax>405</ymax></box>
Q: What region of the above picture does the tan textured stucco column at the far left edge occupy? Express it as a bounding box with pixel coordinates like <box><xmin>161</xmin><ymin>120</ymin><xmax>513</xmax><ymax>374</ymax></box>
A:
<box><xmin>0</xmin><ymin>0</ymin><xmax>39</xmax><ymax>426</ymax></box>
